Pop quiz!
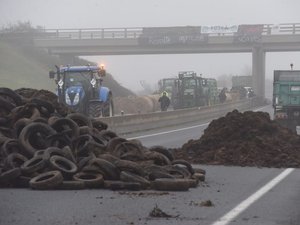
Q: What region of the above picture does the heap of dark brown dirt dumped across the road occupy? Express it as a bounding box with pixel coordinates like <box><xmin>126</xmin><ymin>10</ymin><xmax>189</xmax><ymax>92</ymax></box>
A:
<box><xmin>175</xmin><ymin>110</ymin><xmax>300</xmax><ymax>168</ymax></box>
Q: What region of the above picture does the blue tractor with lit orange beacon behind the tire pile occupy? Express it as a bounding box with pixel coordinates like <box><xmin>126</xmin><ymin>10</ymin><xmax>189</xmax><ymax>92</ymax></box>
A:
<box><xmin>49</xmin><ymin>65</ymin><xmax>114</xmax><ymax>118</ymax></box>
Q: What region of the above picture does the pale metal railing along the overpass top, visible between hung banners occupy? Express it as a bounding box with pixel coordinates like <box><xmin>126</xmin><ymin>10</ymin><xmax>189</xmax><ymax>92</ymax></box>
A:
<box><xmin>0</xmin><ymin>23</ymin><xmax>300</xmax><ymax>39</ymax></box>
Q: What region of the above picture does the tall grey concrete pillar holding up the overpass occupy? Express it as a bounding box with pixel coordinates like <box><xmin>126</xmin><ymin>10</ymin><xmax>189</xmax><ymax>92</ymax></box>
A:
<box><xmin>252</xmin><ymin>47</ymin><xmax>266</xmax><ymax>97</ymax></box>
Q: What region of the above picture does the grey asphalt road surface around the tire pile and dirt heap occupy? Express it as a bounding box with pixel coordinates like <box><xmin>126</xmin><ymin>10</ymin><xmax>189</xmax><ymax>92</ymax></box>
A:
<box><xmin>0</xmin><ymin>105</ymin><xmax>300</xmax><ymax>225</ymax></box>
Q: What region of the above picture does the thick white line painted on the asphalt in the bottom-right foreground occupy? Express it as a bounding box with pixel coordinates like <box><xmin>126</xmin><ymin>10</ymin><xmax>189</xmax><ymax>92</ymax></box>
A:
<box><xmin>211</xmin><ymin>168</ymin><xmax>295</xmax><ymax>225</ymax></box>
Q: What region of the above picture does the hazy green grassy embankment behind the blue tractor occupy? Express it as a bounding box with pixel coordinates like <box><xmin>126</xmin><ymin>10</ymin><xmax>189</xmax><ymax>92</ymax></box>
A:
<box><xmin>0</xmin><ymin>39</ymin><xmax>134</xmax><ymax>96</ymax></box>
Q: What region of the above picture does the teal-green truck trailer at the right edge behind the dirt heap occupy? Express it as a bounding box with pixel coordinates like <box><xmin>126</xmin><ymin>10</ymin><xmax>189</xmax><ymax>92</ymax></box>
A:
<box><xmin>273</xmin><ymin>70</ymin><xmax>300</xmax><ymax>132</ymax></box>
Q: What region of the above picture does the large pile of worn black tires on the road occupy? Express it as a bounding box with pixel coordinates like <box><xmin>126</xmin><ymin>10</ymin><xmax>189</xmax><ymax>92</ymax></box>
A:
<box><xmin>0</xmin><ymin>88</ymin><xmax>205</xmax><ymax>191</ymax></box>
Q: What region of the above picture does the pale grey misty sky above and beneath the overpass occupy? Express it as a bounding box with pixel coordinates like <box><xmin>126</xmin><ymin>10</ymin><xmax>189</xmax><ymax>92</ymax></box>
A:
<box><xmin>0</xmin><ymin>0</ymin><xmax>300</xmax><ymax>97</ymax></box>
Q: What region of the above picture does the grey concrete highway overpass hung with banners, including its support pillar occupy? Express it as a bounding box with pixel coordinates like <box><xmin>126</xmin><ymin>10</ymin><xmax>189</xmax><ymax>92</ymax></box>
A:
<box><xmin>29</xmin><ymin>23</ymin><xmax>300</xmax><ymax>96</ymax></box>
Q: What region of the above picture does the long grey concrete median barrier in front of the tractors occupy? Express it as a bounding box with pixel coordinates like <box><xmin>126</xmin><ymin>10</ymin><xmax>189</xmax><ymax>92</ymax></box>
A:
<box><xmin>101</xmin><ymin>97</ymin><xmax>267</xmax><ymax>135</ymax></box>
